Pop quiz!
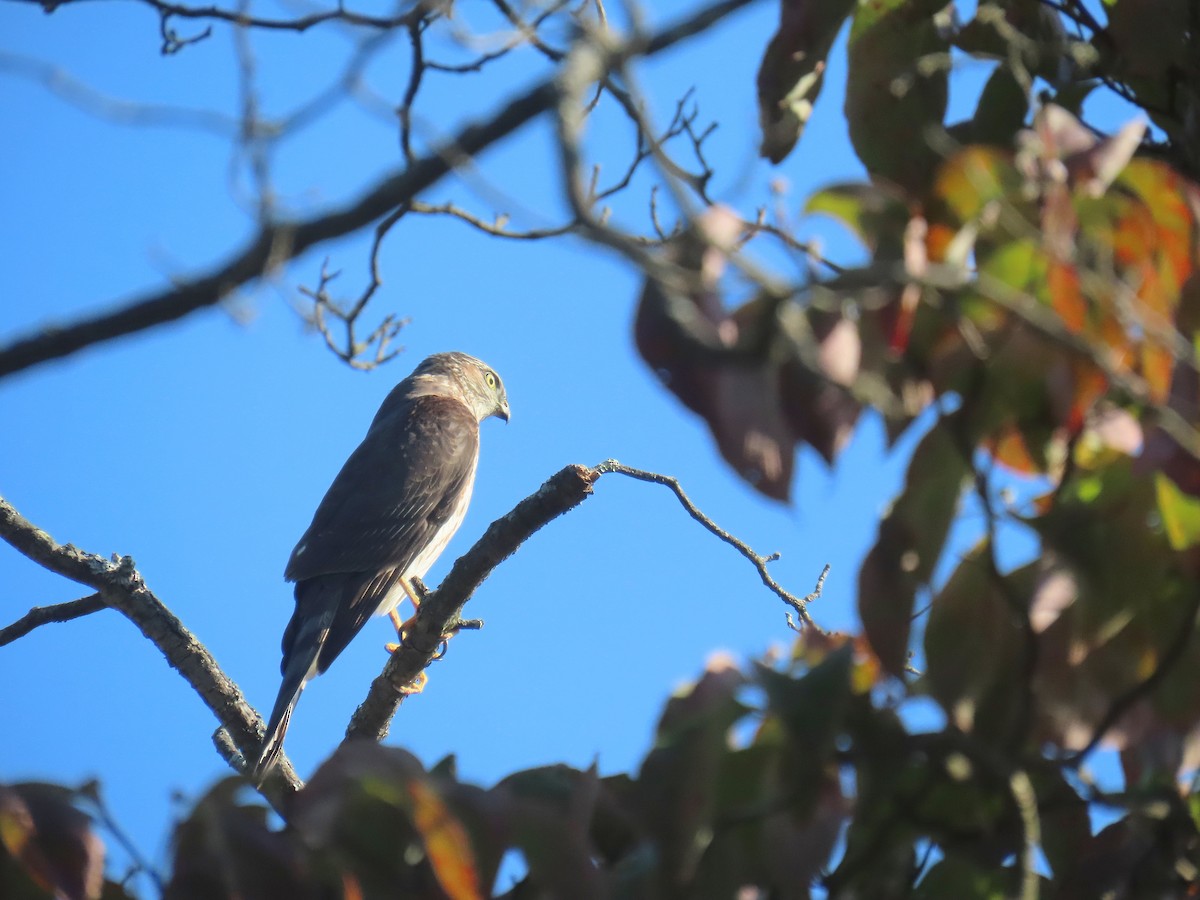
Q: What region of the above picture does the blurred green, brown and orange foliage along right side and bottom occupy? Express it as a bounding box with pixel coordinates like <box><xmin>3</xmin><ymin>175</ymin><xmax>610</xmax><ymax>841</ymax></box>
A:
<box><xmin>7</xmin><ymin>0</ymin><xmax>1200</xmax><ymax>900</ymax></box>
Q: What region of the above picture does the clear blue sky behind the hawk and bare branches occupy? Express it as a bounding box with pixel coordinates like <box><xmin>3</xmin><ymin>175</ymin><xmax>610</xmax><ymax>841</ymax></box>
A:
<box><xmin>0</xmin><ymin>2</ymin><xmax>1123</xmax><ymax>892</ymax></box>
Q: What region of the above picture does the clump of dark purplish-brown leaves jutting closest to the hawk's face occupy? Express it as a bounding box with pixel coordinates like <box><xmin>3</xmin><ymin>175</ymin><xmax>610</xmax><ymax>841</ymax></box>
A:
<box><xmin>634</xmin><ymin>211</ymin><xmax>862</xmax><ymax>502</ymax></box>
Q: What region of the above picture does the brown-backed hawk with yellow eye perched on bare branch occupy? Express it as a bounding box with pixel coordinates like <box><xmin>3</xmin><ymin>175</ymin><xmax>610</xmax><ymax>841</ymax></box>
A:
<box><xmin>253</xmin><ymin>353</ymin><xmax>509</xmax><ymax>780</ymax></box>
